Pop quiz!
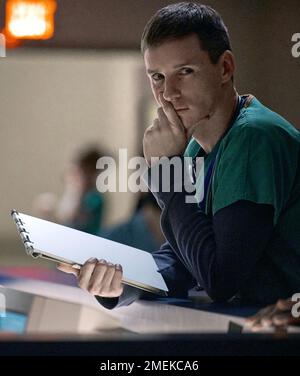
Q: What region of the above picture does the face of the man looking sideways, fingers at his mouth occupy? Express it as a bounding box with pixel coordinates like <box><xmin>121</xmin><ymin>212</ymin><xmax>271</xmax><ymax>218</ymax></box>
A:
<box><xmin>144</xmin><ymin>34</ymin><xmax>222</xmax><ymax>138</ymax></box>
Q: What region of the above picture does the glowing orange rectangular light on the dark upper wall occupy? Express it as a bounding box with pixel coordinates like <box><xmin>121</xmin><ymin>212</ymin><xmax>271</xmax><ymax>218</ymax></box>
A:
<box><xmin>5</xmin><ymin>0</ymin><xmax>56</xmax><ymax>39</ymax></box>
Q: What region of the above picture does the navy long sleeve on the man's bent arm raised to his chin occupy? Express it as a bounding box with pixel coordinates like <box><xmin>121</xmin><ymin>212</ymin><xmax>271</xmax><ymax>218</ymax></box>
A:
<box><xmin>155</xmin><ymin>175</ymin><xmax>274</xmax><ymax>301</ymax></box>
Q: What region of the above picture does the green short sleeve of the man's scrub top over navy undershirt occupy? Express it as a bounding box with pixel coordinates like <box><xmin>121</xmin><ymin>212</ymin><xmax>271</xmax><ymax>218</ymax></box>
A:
<box><xmin>212</xmin><ymin>125</ymin><xmax>298</xmax><ymax>225</ymax></box>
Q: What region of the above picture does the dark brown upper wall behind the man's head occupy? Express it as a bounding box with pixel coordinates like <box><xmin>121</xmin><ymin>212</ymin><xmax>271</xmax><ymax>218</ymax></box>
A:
<box><xmin>0</xmin><ymin>0</ymin><xmax>300</xmax><ymax>128</ymax></box>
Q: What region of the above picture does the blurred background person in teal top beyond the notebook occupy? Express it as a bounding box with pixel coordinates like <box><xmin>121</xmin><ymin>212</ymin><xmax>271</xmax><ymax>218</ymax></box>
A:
<box><xmin>33</xmin><ymin>147</ymin><xmax>105</xmax><ymax>234</ymax></box>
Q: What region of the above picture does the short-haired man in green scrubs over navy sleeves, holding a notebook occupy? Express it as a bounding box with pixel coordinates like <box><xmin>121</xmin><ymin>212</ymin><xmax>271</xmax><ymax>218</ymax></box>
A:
<box><xmin>60</xmin><ymin>3</ymin><xmax>300</xmax><ymax>308</ymax></box>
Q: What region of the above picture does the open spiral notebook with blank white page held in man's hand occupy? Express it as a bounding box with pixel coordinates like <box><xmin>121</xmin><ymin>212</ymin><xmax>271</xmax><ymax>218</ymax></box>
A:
<box><xmin>11</xmin><ymin>210</ymin><xmax>168</xmax><ymax>295</ymax></box>
